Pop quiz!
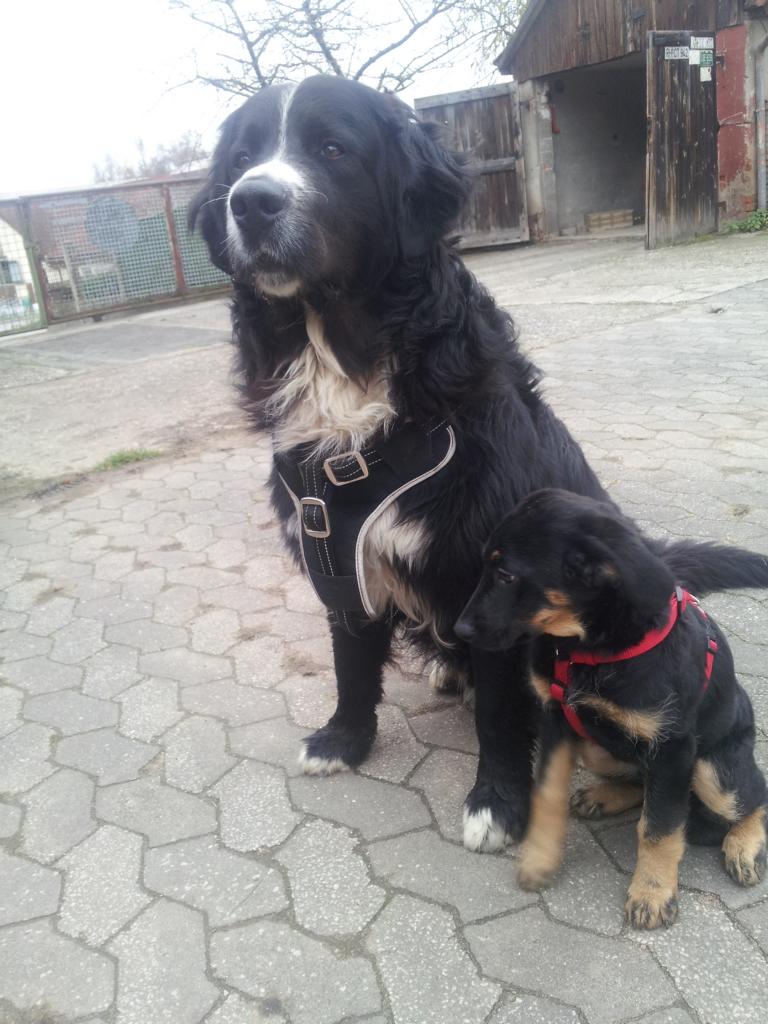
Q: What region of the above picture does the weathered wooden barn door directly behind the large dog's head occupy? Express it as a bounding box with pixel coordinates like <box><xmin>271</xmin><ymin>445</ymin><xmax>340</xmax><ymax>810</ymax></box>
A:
<box><xmin>416</xmin><ymin>83</ymin><xmax>528</xmax><ymax>249</ymax></box>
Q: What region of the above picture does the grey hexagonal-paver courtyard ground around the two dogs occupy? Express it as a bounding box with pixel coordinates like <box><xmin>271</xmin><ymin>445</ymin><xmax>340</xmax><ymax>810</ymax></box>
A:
<box><xmin>0</xmin><ymin>234</ymin><xmax>768</xmax><ymax>1024</ymax></box>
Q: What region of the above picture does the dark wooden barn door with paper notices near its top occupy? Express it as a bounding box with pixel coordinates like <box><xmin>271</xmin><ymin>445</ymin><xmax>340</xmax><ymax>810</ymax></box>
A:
<box><xmin>645</xmin><ymin>32</ymin><xmax>718</xmax><ymax>249</ymax></box>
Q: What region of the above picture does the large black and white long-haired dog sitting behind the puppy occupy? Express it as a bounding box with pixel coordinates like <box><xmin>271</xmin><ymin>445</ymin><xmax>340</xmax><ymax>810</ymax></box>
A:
<box><xmin>191</xmin><ymin>76</ymin><xmax>605</xmax><ymax>850</ymax></box>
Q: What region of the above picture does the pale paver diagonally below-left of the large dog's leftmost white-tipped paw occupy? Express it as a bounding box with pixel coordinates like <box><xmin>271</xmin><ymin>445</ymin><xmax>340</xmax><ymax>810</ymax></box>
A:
<box><xmin>211</xmin><ymin>763</ymin><xmax>300</xmax><ymax>853</ymax></box>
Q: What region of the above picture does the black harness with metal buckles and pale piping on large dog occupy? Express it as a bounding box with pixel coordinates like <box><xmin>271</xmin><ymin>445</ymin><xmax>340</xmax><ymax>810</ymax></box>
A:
<box><xmin>274</xmin><ymin>421</ymin><xmax>456</xmax><ymax>635</ymax></box>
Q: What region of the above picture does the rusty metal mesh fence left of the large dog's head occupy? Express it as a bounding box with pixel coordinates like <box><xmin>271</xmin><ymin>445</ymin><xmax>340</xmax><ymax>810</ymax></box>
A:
<box><xmin>0</xmin><ymin>176</ymin><xmax>227</xmax><ymax>334</ymax></box>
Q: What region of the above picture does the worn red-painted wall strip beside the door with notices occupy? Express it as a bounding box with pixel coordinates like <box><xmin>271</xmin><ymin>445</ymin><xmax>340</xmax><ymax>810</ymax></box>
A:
<box><xmin>717</xmin><ymin>25</ymin><xmax>756</xmax><ymax>218</ymax></box>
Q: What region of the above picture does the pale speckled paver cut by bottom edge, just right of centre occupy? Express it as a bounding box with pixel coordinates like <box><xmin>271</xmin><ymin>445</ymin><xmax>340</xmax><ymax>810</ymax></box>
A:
<box><xmin>366</xmin><ymin>896</ymin><xmax>501</xmax><ymax>1024</ymax></box>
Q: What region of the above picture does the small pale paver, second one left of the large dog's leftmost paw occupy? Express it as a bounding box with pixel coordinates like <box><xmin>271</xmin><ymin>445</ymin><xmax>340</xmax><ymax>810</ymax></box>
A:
<box><xmin>163</xmin><ymin>716</ymin><xmax>236</xmax><ymax>793</ymax></box>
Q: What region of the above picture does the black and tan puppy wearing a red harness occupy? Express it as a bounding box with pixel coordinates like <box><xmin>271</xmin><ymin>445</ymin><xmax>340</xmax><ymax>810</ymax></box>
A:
<box><xmin>456</xmin><ymin>489</ymin><xmax>768</xmax><ymax>929</ymax></box>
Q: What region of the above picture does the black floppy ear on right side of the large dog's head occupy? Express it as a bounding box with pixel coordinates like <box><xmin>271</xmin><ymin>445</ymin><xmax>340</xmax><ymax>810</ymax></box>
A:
<box><xmin>401</xmin><ymin>115</ymin><xmax>473</xmax><ymax>256</ymax></box>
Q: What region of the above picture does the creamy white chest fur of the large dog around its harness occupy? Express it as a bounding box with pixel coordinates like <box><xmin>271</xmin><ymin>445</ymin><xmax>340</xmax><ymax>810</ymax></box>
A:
<box><xmin>269</xmin><ymin>312</ymin><xmax>426</xmax><ymax>622</ymax></box>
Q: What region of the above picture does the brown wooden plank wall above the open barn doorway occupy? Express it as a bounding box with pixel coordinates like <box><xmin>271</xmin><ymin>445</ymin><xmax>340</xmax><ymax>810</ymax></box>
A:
<box><xmin>511</xmin><ymin>0</ymin><xmax>720</xmax><ymax>82</ymax></box>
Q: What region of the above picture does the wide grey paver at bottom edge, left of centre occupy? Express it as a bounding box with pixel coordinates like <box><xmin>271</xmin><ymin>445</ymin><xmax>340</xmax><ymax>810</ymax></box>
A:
<box><xmin>211</xmin><ymin>921</ymin><xmax>381</xmax><ymax>1024</ymax></box>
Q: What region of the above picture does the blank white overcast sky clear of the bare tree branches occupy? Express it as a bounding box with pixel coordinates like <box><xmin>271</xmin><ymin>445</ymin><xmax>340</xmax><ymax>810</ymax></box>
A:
<box><xmin>0</xmin><ymin>0</ymin><xmax>493</xmax><ymax>195</ymax></box>
